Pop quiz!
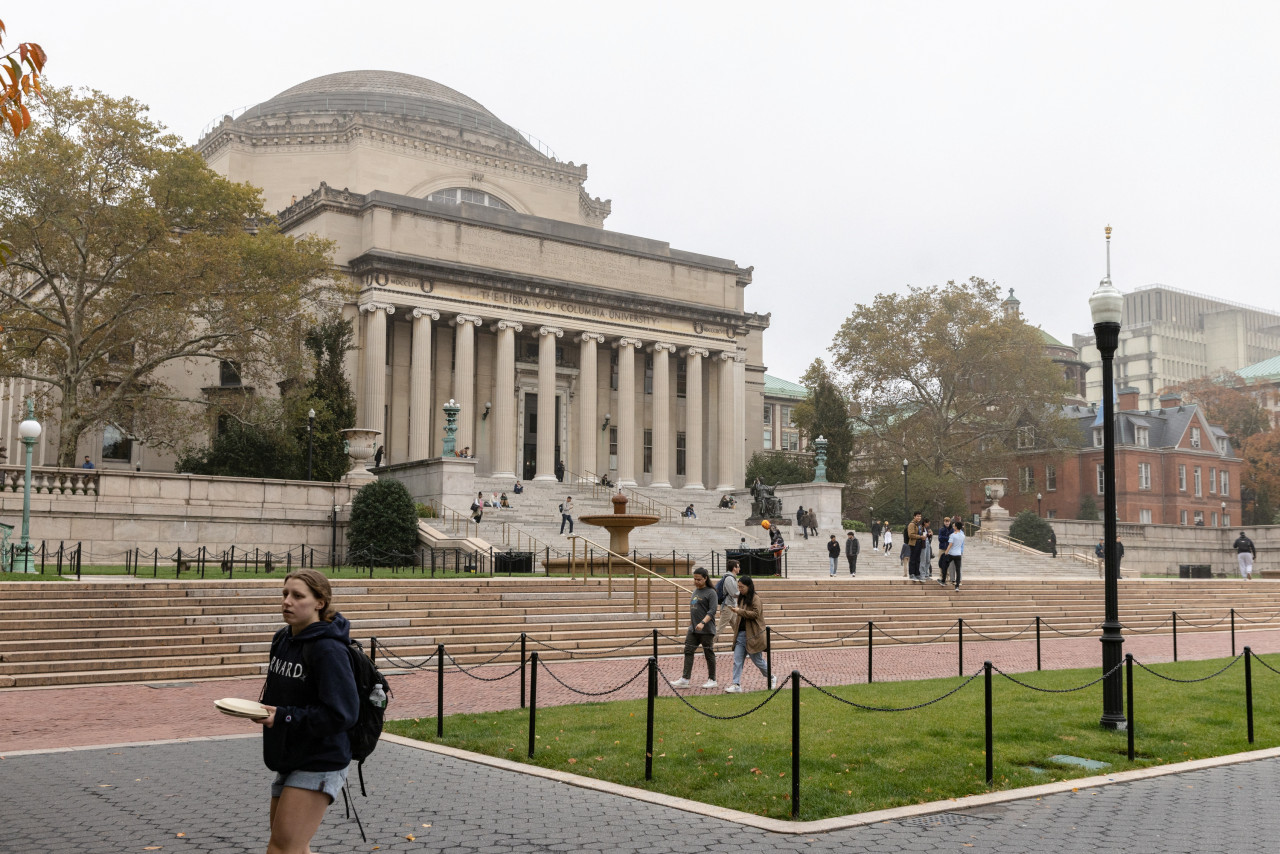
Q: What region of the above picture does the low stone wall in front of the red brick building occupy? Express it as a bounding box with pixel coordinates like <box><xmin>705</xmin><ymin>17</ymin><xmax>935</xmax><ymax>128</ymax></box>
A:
<box><xmin>1048</xmin><ymin>519</ymin><xmax>1280</xmax><ymax>576</ymax></box>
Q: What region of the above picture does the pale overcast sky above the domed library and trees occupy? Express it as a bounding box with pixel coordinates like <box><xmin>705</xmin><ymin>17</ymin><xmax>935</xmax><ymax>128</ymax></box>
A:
<box><xmin>12</xmin><ymin>0</ymin><xmax>1280</xmax><ymax>379</ymax></box>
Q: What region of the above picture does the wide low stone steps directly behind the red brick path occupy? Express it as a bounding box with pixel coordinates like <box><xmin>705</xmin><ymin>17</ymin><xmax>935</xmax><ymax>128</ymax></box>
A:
<box><xmin>0</xmin><ymin>573</ymin><xmax>1280</xmax><ymax>688</ymax></box>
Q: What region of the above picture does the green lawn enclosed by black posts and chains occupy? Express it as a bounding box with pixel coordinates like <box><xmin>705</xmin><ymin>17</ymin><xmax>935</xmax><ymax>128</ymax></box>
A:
<box><xmin>387</xmin><ymin>657</ymin><xmax>1280</xmax><ymax>819</ymax></box>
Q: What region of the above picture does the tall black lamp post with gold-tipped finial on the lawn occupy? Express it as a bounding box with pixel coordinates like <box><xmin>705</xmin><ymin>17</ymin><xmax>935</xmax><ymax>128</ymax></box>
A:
<box><xmin>1089</xmin><ymin>225</ymin><xmax>1128</xmax><ymax>730</ymax></box>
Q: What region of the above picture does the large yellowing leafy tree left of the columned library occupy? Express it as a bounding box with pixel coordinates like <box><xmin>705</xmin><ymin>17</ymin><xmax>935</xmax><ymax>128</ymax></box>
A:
<box><xmin>0</xmin><ymin>83</ymin><xmax>332</xmax><ymax>466</ymax></box>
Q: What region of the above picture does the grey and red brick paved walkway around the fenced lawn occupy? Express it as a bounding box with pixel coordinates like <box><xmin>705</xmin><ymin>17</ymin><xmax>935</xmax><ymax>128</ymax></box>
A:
<box><xmin>0</xmin><ymin>630</ymin><xmax>1280</xmax><ymax>854</ymax></box>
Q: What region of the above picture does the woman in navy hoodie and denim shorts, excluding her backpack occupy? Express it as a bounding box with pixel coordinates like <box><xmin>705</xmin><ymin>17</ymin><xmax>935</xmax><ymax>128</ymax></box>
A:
<box><xmin>259</xmin><ymin>570</ymin><xmax>360</xmax><ymax>854</ymax></box>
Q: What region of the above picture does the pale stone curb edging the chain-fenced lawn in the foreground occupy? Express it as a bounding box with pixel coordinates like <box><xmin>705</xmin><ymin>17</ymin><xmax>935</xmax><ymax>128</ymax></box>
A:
<box><xmin>381</xmin><ymin>732</ymin><xmax>1280</xmax><ymax>835</ymax></box>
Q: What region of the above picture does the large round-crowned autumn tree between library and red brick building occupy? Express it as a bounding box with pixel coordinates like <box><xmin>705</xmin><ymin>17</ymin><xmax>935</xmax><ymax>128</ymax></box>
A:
<box><xmin>831</xmin><ymin>278</ymin><xmax>1073</xmax><ymax>507</ymax></box>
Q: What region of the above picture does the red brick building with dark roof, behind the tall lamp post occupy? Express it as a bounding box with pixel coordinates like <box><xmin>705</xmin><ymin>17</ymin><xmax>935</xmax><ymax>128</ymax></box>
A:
<box><xmin>970</xmin><ymin>388</ymin><xmax>1243</xmax><ymax>528</ymax></box>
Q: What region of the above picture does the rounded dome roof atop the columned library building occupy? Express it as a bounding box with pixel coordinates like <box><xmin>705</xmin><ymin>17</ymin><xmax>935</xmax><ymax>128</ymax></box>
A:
<box><xmin>227</xmin><ymin>70</ymin><xmax>532</xmax><ymax>149</ymax></box>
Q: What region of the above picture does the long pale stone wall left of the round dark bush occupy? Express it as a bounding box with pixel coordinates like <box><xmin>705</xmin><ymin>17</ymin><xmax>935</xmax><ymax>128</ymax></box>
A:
<box><xmin>0</xmin><ymin>466</ymin><xmax>356</xmax><ymax>563</ymax></box>
